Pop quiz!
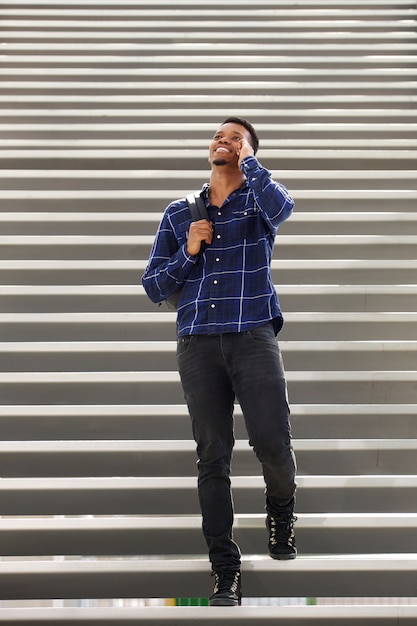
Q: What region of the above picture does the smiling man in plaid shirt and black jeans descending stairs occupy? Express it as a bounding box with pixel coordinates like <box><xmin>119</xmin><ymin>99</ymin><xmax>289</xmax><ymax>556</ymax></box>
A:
<box><xmin>142</xmin><ymin>117</ymin><xmax>296</xmax><ymax>606</ymax></box>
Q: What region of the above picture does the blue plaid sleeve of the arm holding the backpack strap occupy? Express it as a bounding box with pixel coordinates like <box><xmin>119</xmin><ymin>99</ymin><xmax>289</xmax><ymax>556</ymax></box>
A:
<box><xmin>142</xmin><ymin>207</ymin><xmax>198</xmax><ymax>302</ymax></box>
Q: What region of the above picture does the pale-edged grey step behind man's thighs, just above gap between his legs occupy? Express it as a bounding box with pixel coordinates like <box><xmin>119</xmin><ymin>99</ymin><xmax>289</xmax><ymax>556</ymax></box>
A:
<box><xmin>0</xmin><ymin>370</ymin><xmax>417</xmax><ymax>404</ymax></box>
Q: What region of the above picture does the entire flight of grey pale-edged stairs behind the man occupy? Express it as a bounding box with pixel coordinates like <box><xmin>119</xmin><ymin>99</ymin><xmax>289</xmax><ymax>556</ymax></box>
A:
<box><xmin>0</xmin><ymin>0</ymin><xmax>417</xmax><ymax>626</ymax></box>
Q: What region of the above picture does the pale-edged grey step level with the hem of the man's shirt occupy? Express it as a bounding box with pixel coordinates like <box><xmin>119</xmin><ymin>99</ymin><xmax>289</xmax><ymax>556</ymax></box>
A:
<box><xmin>0</xmin><ymin>307</ymin><xmax>417</xmax><ymax>338</ymax></box>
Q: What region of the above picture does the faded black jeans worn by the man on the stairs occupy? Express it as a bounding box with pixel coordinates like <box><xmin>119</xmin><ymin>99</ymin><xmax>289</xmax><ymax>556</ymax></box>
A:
<box><xmin>177</xmin><ymin>324</ymin><xmax>296</xmax><ymax>571</ymax></box>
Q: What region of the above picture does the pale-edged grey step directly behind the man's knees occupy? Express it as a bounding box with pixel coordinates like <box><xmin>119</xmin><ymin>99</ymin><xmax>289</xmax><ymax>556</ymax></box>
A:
<box><xmin>0</xmin><ymin>436</ymin><xmax>417</xmax><ymax>478</ymax></box>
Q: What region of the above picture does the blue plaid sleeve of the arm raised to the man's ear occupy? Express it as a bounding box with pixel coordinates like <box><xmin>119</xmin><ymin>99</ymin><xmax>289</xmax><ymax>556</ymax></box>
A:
<box><xmin>241</xmin><ymin>156</ymin><xmax>295</xmax><ymax>230</ymax></box>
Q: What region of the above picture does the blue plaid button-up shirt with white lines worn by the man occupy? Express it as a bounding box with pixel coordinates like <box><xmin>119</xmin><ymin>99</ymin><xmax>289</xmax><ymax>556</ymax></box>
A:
<box><xmin>142</xmin><ymin>156</ymin><xmax>294</xmax><ymax>336</ymax></box>
